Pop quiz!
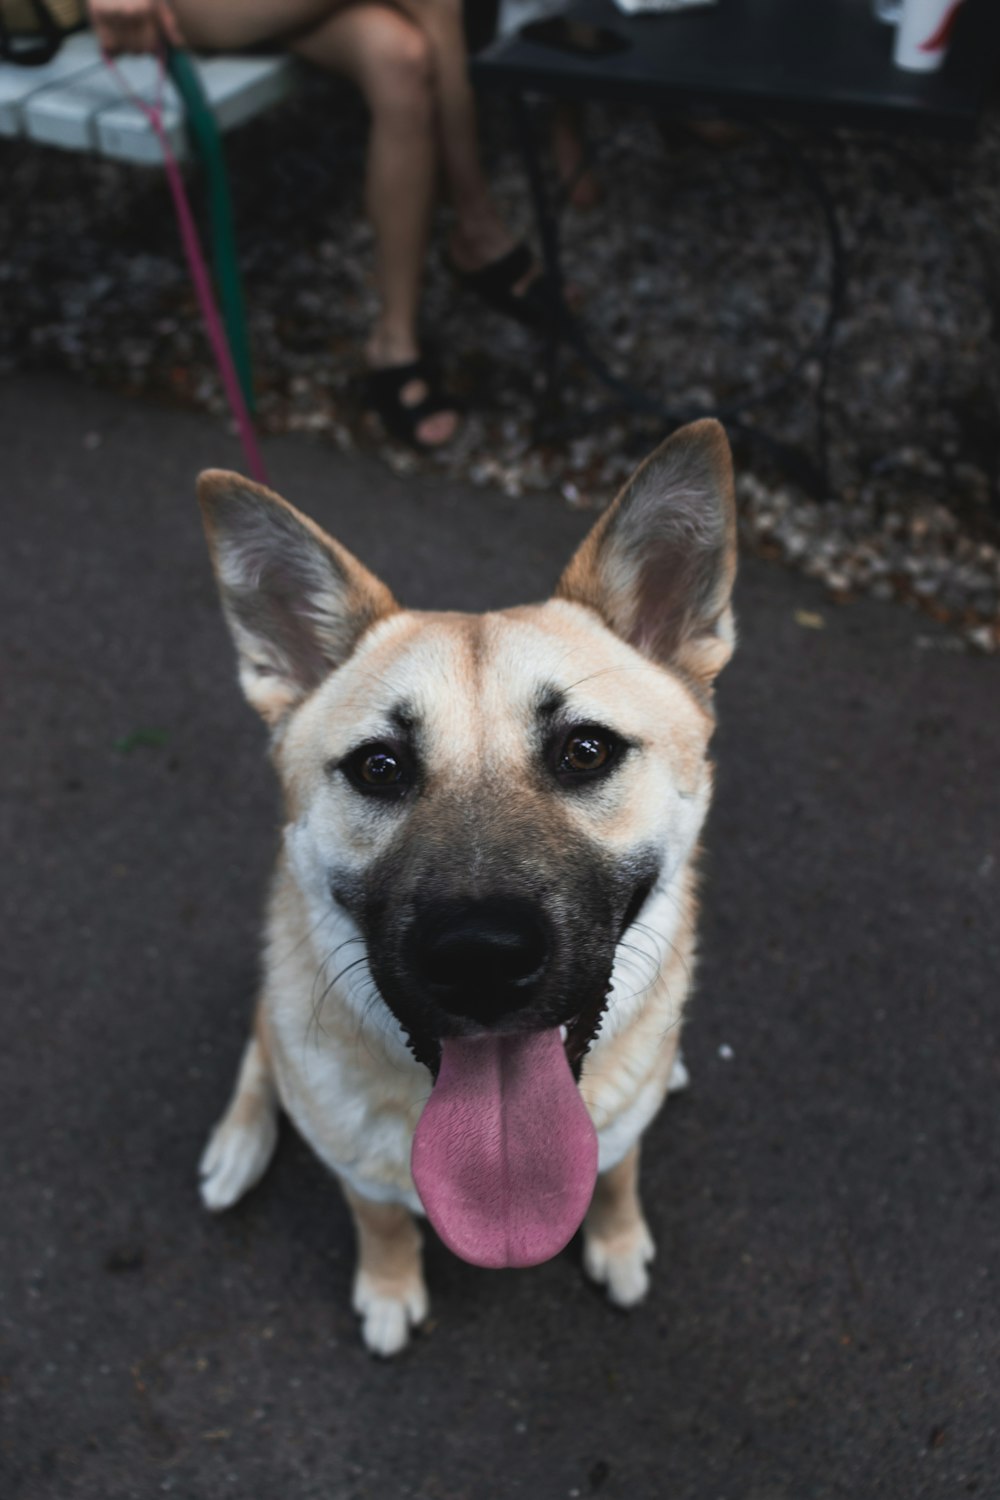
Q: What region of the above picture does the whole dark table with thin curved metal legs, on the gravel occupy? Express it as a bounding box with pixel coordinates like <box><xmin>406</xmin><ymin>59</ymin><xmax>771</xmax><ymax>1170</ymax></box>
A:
<box><xmin>472</xmin><ymin>0</ymin><xmax>1000</xmax><ymax>492</ymax></box>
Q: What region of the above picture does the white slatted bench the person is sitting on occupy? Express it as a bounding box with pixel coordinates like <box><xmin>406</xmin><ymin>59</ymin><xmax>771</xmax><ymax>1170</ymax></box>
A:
<box><xmin>0</xmin><ymin>32</ymin><xmax>292</xmax><ymax>167</ymax></box>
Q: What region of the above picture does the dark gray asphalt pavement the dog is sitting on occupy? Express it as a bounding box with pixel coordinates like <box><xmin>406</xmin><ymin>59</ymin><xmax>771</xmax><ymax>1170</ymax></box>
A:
<box><xmin>0</xmin><ymin>378</ymin><xmax>1000</xmax><ymax>1500</ymax></box>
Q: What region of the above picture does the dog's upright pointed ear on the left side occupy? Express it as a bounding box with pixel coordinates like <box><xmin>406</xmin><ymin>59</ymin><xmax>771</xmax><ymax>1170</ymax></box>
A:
<box><xmin>198</xmin><ymin>470</ymin><xmax>397</xmax><ymax>725</ymax></box>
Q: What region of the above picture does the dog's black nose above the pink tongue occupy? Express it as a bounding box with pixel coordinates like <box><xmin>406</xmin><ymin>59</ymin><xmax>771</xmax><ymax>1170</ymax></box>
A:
<box><xmin>411</xmin><ymin>897</ymin><xmax>549</xmax><ymax>1025</ymax></box>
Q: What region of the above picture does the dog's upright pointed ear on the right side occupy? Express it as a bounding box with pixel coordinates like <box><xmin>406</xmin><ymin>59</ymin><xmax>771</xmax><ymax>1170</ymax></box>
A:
<box><xmin>556</xmin><ymin>420</ymin><xmax>736</xmax><ymax>692</ymax></box>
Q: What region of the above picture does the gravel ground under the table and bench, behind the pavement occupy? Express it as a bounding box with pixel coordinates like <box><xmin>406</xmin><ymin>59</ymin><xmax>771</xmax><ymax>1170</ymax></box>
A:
<box><xmin>0</xmin><ymin>78</ymin><xmax>1000</xmax><ymax>651</ymax></box>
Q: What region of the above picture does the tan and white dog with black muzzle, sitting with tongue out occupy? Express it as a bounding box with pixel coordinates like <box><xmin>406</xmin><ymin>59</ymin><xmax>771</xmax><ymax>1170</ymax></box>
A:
<box><xmin>198</xmin><ymin>420</ymin><xmax>736</xmax><ymax>1356</ymax></box>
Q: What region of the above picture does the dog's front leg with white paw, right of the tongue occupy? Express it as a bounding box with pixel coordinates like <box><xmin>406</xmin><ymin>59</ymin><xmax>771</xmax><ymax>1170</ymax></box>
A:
<box><xmin>583</xmin><ymin>1143</ymin><xmax>655</xmax><ymax>1308</ymax></box>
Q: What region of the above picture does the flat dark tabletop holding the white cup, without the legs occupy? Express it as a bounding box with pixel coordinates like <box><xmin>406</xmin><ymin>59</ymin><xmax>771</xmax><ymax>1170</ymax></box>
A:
<box><xmin>472</xmin><ymin>0</ymin><xmax>1000</xmax><ymax>138</ymax></box>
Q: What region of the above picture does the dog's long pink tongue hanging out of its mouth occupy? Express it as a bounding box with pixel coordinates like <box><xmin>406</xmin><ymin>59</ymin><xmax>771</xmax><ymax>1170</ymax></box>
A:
<box><xmin>412</xmin><ymin>1031</ymin><xmax>597</xmax><ymax>1268</ymax></box>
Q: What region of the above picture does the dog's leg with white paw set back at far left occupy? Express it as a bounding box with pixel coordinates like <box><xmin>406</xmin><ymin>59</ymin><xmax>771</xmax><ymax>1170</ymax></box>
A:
<box><xmin>198</xmin><ymin>1025</ymin><xmax>277</xmax><ymax>1214</ymax></box>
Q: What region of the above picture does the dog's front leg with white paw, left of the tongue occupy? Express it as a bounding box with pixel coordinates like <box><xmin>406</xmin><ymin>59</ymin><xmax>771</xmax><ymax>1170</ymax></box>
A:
<box><xmin>342</xmin><ymin>1184</ymin><xmax>429</xmax><ymax>1356</ymax></box>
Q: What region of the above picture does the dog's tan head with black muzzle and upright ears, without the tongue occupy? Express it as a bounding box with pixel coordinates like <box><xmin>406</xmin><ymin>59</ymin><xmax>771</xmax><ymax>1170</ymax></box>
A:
<box><xmin>199</xmin><ymin>422</ymin><xmax>736</xmax><ymax>1071</ymax></box>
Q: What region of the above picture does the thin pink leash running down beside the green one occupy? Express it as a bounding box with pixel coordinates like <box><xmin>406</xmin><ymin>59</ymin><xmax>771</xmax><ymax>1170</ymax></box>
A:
<box><xmin>103</xmin><ymin>44</ymin><xmax>267</xmax><ymax>485</ymax></box>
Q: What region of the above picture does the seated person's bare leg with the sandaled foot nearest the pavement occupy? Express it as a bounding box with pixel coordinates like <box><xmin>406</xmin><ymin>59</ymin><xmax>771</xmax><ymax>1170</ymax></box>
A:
<box><xmin>170</xmin><ymin>0</ymin><xmax>457</xmax><ymax>446</ymax></box>
